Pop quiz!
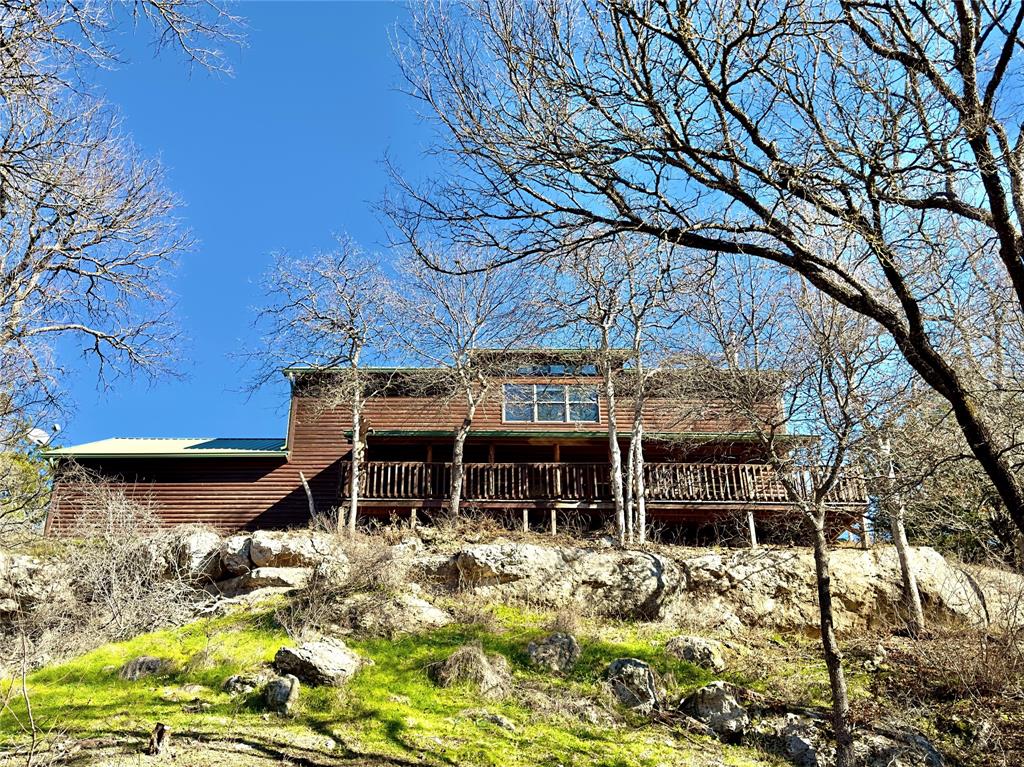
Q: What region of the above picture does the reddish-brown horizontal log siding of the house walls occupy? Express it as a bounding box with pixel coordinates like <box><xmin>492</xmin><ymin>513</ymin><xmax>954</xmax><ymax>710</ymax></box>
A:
<box><xmin>41</xmin><ymin>379</ymin><xmax>774</xmax><ymax>531</ymax></box>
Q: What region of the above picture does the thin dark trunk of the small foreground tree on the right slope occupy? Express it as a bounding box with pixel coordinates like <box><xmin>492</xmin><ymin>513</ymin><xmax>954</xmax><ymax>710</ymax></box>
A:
<box><xmin>812</xmin><ymin>510</ymin><xmax>854</xmax><ymax>767</ymax></box>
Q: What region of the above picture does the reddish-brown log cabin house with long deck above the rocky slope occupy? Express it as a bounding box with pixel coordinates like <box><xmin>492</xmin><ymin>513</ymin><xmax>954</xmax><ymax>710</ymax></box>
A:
<box><xmin>47</xmin><ymin>350</ymin><xmax>865</xmax><ymax>531</ymax></box>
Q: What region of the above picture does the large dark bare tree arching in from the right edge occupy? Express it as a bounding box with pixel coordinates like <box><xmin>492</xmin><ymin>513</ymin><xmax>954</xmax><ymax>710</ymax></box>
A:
<box><xmin>392</xmin><ymin>0</ymin><xmax>1024</xmax><ymax>529</ymax></box>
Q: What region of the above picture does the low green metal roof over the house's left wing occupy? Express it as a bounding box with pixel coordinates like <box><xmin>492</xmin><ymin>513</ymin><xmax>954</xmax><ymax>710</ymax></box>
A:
<box><xmin>45</xmin><ymin>437</ymin><xmax>288</xmax><ymax>458</ymax></box>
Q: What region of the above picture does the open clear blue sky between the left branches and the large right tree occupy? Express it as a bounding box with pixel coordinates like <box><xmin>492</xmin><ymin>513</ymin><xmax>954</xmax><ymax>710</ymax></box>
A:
<box><xmin>59</xmin><ymin>2</ymin><xmax>430</xmax><ymax>444</ymax></box>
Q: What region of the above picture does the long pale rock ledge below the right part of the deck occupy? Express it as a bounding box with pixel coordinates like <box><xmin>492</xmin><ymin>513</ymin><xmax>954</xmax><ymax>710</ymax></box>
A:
<box><xmin>423</xmin><ymin>543</ymin><xmax>1024</xmax><ymax>635</ymax></box>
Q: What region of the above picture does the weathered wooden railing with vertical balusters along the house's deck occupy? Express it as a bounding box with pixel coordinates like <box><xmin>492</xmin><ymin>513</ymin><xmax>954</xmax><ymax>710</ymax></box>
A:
<box><xmin>346</xmin><ymin>461</ymin><xmax>866</xmax><ymax>504</ymax></box>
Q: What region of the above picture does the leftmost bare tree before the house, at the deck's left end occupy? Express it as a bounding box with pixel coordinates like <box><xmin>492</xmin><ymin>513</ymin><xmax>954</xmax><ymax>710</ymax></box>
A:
<box><xmin>256</xmin><ymin>237</ymin><xmax>391</xmax><ymax>536</ymax></box>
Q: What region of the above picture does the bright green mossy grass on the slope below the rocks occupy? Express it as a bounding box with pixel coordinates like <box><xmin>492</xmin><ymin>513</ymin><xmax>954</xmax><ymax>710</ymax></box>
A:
<box><xmin>0</xmin><ymin>607</ymin><xmax>780</xmax><ymax>767</ymax></box>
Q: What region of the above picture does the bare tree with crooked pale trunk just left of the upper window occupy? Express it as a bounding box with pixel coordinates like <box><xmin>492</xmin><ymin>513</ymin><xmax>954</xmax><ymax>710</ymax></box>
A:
<box><xmin>391</xmin><ymin>246</ymin><xmax>541</xmax><ymax>516</ymax></box>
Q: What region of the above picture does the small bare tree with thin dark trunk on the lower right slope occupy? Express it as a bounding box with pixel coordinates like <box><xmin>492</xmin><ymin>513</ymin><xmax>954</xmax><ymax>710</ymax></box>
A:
<box><xmin>696</xmin><ymin>260</ymin><xmax>913</xmax><ymax>766</ymax></box>
